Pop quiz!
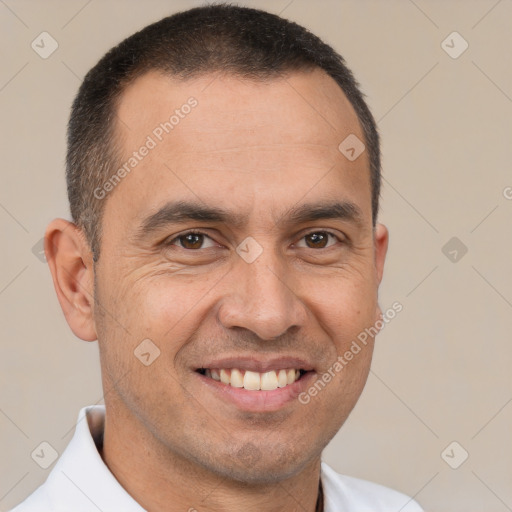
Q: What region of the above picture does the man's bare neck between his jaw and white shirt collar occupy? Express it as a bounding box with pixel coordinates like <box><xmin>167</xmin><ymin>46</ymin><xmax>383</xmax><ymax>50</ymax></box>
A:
<box><xmin>100</xmin><ymin>406</ymin><xmax>323</xmax><ymax>512</ymax></box>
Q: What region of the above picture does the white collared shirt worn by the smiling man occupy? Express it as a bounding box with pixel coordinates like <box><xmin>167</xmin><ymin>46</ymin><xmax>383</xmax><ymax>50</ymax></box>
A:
<box><xmin>11</xmin><ymin>406</ymin><xmax>422</xmax><ymax>512</ymax></box>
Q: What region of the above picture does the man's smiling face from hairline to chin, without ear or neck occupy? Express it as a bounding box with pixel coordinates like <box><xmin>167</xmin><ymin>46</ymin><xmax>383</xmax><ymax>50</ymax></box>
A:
<box><xmin>94</xmin><ymin>71</ymin><xmax>386</xmax><ymax>482</ymax></box>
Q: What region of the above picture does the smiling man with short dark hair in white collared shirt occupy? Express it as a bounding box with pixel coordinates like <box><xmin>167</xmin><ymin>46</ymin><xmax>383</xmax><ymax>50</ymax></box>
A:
<box><xmin>15</xmin><ymin>5</ymin><xmax>421</xmax><ymax>512</ymax></box>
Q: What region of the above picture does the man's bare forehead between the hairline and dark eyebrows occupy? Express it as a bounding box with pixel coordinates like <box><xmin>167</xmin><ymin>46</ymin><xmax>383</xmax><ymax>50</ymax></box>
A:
<box><xmin>104</xmin><ymin>70</ymin><xmax>371</xmax><ymax>230</ymax></box>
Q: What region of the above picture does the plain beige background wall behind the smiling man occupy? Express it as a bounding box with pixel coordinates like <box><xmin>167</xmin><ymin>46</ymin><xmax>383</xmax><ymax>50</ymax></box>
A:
<box><xmin>0</xmin><ymin>0</ymin><xmax>512</xmax><ymax>512</ymax></box>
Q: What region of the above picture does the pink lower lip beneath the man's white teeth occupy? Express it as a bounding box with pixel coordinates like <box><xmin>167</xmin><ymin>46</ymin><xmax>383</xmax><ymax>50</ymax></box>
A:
<box><xmin>194</xmin><ymin>365</ymin><xmax>317</xmax><ymax>413</ymax></box>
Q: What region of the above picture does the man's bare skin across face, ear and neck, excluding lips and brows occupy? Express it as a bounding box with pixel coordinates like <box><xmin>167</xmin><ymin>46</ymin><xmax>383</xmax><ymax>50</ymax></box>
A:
<box><xmin>46</xmin><ymin>70</ymin><xmax>388</xmax><ymax>511</ymax></box>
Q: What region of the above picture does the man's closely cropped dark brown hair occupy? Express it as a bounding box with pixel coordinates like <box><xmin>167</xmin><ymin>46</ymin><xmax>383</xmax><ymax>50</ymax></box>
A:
<box><xmin>66</xmin><ymin>4</ymin><xmax>381</xmax><ymax>261</ymax></box>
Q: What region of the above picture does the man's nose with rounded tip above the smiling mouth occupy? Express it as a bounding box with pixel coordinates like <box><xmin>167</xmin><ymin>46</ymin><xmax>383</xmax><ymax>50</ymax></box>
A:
<box><xmin>218</xmin><ymin>251</ymin><xmax>307</xmax><ymax>340</ymax></box>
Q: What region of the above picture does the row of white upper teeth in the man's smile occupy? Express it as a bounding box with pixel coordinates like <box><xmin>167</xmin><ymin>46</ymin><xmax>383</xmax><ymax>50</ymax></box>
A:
<box><xmin>205</xmin><ymin>368</ymin><xmax>300</xmax><ymax>391</ymax></box>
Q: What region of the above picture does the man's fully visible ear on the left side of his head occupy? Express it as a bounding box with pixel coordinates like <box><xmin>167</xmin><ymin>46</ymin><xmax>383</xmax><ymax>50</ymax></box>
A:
<box><xmin>44</xmin><ymin>219</ymin><xmax>97</xmax><ymax>341</ymax></box>
